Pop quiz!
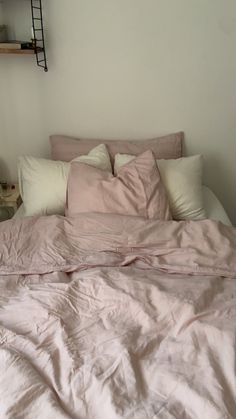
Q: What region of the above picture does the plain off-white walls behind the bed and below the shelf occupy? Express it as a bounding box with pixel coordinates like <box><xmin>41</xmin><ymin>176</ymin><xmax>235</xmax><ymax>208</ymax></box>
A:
<box><xmin>0</xmin><ymin>0</ymin><xmax>236</xmax><ymax>223</ymax></box>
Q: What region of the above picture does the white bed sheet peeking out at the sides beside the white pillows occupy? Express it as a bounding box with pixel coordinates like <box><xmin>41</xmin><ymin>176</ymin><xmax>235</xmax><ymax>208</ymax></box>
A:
<box><xmin>13</xmin><ymin>186</ymin><xmax>232</xmax><ymax>226</ymax></box>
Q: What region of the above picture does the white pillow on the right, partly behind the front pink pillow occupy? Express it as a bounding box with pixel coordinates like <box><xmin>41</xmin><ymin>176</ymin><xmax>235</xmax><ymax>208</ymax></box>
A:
<box><xmin>114</xmin><ymin>154</ymin><xmax>206</xmax><ymax>220</ymax></box>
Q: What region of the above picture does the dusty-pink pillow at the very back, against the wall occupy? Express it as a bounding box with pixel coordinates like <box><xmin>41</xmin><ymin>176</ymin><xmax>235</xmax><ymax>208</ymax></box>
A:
<box><xmin>50</xmin><ymin>132</ymin><xmax>184</xmax><ymax>161</ymax></box>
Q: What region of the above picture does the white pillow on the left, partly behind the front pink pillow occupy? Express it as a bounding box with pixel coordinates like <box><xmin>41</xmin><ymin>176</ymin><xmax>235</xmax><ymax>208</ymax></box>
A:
<box><xmin>18</xmin><ymin>144</ymin><xmax>112</xmax><ymax>216</ymax></box>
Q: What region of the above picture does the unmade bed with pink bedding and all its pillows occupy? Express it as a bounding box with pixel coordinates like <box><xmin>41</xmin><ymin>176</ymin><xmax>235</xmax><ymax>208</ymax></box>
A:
<box><xmin>0</xmin><ymin>133</ymin><xmax>236</xmax><ymax>419</ymax></box>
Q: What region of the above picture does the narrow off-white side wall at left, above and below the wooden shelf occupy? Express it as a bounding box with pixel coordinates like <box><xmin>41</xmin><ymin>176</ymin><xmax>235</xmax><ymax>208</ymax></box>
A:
<box><xmin>0</xmin><ymin>0</ymin><xmax>48</xmax><ymax>180</ymax></box>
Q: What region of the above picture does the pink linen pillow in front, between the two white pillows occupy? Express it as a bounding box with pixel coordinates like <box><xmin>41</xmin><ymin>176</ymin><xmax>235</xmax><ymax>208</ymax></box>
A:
<box><xmin>66</xmin><ymin>150</ymin><xmax>172</xmax><ymax>220</ymax></box>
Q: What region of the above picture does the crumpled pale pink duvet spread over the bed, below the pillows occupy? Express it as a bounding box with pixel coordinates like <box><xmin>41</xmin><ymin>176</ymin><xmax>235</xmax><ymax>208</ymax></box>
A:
<box><xmin>0</xmin><ymin>214</ymin><xmax>236</xmax><ymax>419</ymax></box>
